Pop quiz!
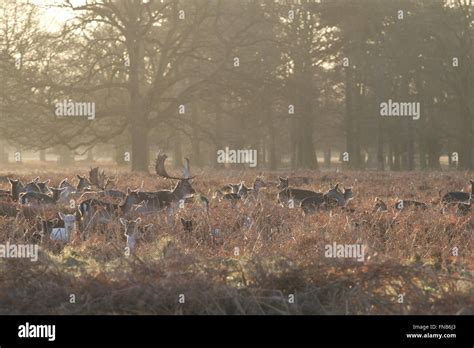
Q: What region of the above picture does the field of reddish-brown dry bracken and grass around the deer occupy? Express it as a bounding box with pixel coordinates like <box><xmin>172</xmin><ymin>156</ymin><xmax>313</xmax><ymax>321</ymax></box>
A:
<box><xmin>0</xmin><ymin>166</ymin><xmax>474</xmax><ymax>314</ymax></box>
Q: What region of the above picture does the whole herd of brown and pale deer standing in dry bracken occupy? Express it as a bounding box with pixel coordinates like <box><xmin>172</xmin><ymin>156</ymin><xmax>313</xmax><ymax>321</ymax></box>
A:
<box><xmin>0</xmin><ymin>153</ymin><xmax>474</xmax><ymax>250</ymax></box>
